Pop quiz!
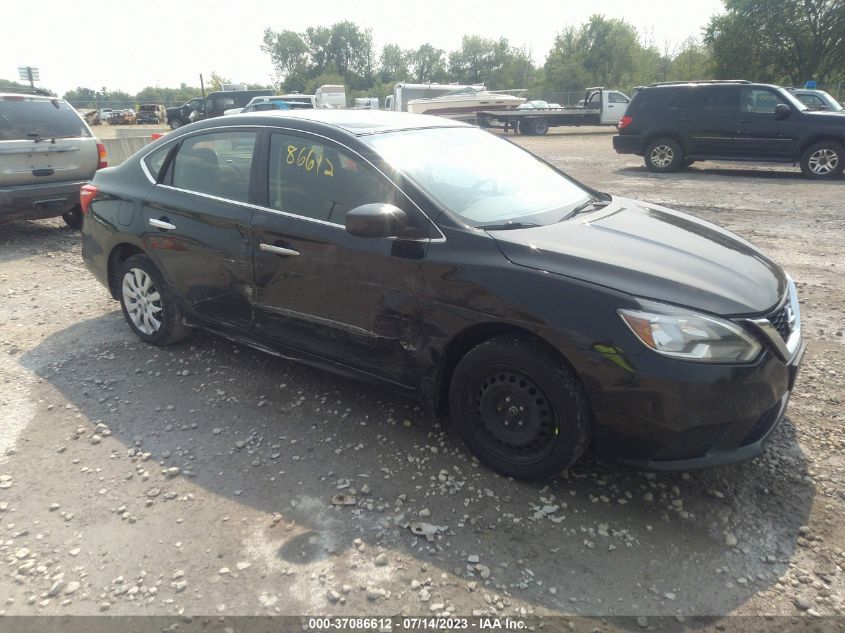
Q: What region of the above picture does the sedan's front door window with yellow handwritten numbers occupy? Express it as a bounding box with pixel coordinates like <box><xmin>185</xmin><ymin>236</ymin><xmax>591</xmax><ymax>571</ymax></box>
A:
<box><xmin>269</xmin><ymin>134</ymin><xmax>398</xmax><ymax>226</ymax></box>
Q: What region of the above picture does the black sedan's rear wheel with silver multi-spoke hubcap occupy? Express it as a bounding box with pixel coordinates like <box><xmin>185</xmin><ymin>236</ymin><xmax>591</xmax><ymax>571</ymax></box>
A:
<box><xmin>116</xmin><ymin>254</ymin><xmax>191</xmax><ymax>346</ymax></box>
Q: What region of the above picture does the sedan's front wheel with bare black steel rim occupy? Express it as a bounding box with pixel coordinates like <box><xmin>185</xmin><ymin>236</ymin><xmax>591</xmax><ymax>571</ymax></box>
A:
<box><xmin>449</xmin><ymin>335</ymin><xmax>593</xmax><ymax>481</ymax></box>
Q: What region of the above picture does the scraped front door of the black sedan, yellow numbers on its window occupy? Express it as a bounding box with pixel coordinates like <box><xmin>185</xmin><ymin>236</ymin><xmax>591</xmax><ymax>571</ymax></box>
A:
<box><xmin>253</xmin><ymin>133</ymin><xmax>429</xmax><ymax>386</ymax></box>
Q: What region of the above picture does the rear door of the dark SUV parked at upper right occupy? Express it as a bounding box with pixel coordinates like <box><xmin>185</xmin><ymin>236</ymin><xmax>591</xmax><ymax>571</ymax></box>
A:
<box><xmin>678</xmin><ymin>85</ymin><xmax>739</xmax><ymax>157</ymax></box>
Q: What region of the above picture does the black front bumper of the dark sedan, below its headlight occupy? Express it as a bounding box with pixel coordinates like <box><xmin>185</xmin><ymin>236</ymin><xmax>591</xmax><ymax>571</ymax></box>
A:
<box><xmin>594</xmin><ymin>334</ymin><xmax>806</xmax><ymax>471</ymax></box>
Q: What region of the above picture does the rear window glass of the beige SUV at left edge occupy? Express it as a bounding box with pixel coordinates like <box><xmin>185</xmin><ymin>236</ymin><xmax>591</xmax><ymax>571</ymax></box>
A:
<box><xmin>0</xmin><ymin>97</ymin><xmax>91</xmax><ymax>141</ymax></box>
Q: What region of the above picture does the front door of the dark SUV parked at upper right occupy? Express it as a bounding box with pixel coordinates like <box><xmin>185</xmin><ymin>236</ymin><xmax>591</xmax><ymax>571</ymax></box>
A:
<box><xmin>737</xmin><ymin>86</ymin><xmax>802</xmax><ymax>161</ymax></box>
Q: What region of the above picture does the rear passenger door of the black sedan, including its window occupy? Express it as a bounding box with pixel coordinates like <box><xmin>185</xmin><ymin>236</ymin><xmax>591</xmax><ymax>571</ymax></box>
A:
<box><xmin>142</xmin><ymin>128</ymin><xmax>258</xmax><ymax>328</ymax></box>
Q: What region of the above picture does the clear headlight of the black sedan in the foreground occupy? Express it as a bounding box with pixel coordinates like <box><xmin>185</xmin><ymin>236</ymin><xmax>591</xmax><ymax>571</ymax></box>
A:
<box><xmin>619</xmin><ymin>301</ymin><xmax>762</xmax><ymax>363</ymax></box>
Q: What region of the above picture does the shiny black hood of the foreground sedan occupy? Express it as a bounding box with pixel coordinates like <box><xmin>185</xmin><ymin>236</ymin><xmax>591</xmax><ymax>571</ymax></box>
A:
<box><xmin>489</xmin><ymin>197</ymin><xmax>787</xmax><ymax>315</ymax></box>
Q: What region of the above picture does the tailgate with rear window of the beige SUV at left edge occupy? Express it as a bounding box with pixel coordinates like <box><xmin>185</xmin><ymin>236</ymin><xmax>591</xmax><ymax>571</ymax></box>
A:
<box><xmin>0</xmin><ymin>95</ymin><xmax>99</xmax><ymax>187</ymax></box>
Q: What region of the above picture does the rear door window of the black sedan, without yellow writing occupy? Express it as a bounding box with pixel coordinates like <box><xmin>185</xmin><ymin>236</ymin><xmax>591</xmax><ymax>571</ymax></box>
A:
<box><xmin>173</xmin><ymin>132</ymin><xmax>255</xmax><ymax>202</ymax></box>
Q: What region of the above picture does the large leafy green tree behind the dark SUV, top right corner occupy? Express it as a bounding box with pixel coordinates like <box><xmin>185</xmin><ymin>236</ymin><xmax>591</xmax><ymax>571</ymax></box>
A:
<box><xmin>705</xmin><ymin>0</ymin><xmax>845</xmax><ymax>85</ymax></box>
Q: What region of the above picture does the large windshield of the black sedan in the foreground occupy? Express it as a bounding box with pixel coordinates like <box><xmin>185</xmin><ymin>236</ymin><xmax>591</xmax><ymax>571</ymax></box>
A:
<box><xmin>362</xmin><ymin>128</ymin><xmax>590</xmax><ymax>226</ymax></box>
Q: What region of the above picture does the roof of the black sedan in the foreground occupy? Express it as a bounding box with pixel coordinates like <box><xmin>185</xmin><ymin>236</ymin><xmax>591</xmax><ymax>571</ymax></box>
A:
<box><xmin>221</xmin><ymin>109</ymin><xmax>471</xmax><ymax>136</ymax></box>
